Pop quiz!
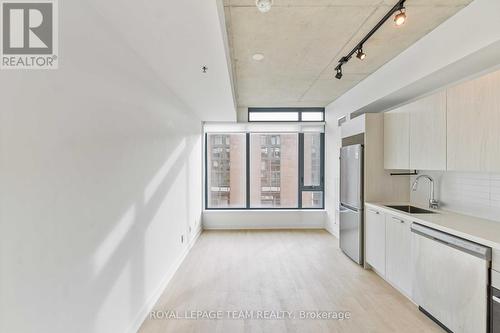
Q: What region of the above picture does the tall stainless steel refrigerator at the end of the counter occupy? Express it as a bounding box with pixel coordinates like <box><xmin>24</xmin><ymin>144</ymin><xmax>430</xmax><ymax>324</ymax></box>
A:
<box><xmin>339</xmin><ymin>145</ymin><xmax>363</xmax><ymax>264</ymax></box>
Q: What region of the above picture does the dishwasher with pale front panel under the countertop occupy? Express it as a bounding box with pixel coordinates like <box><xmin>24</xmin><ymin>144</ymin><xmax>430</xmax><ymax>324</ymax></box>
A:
<box><xmin>411</xmin><ymin>223</ymin><xmax>491</xmax><ymax>333</ymax></box>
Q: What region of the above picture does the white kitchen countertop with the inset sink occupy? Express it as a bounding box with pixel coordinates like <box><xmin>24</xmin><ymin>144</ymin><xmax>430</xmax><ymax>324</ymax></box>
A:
<box><xmin>365</xmin><ymin>202</ymin><xmax>500</xmax><ymax>250</ymax></box>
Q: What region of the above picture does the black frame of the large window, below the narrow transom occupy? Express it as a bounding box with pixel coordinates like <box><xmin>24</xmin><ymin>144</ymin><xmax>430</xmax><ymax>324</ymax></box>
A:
<box><xmin>204</xmin><ymin>132</ymin><xmax>325</xmax><ymax>210</ymax></box>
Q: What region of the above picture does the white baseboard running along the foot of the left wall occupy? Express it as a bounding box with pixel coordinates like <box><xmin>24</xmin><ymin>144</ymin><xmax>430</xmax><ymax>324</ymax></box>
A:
<box><xmin>127</xmin><ymin>225</ymin><xmax>203</xmax><ymax>333</ymax></box>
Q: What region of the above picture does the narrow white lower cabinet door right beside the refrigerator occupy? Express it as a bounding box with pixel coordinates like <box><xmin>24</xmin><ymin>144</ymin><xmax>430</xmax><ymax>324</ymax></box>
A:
<box><xmin>365</xmin><ymin>208</ymin><xmax>385</xmax><ymax>277</ymax></box>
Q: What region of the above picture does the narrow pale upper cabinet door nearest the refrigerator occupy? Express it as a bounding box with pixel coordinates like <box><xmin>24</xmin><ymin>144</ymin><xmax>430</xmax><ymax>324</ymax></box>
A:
<box><xmin>384</xmin><ymin>106</ymin><xmax>410</xmax><ymax>169</ymax></box>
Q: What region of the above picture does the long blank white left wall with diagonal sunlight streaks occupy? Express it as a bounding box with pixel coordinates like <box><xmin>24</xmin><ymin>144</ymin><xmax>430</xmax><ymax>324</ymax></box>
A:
<box><xmin>0</xmin><ymin>1</ymin><xmax>211</xmax><ymax>333</ymax></box>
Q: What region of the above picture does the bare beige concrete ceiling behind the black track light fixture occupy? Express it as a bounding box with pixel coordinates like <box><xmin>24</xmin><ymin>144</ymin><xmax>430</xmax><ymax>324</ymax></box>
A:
<box><xmin>224</xmin><ymin>0</ymin><xmax>472</xmax><ymax>107</ymax></box>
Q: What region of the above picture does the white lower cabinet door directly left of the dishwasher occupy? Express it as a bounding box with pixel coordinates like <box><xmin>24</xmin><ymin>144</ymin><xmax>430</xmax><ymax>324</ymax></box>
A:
<box><xmin>385</xmin><ymin>214</ymin><xmax>412</xmax><ymax>296</ymax></box>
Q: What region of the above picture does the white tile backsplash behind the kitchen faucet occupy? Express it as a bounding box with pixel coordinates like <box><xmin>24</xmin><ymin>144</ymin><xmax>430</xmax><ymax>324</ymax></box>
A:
<box><xmin>410</xmin><ymin>171</ymin><xmax>500</xmax><ymax>222</ymax></box>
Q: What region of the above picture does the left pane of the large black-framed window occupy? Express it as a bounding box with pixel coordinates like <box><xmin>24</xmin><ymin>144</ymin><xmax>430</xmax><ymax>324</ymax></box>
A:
<box><xmin>207</xmin><ymin>133</ymin><xmax>246</xmax><ymax>208</ymax></box>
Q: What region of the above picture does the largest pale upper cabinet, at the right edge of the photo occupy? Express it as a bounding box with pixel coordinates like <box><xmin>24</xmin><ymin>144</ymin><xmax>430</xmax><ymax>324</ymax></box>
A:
<box><xmin>447</xmin><ymin>72</ymin><xmax>500</xmax><ymax>172</ymax></box>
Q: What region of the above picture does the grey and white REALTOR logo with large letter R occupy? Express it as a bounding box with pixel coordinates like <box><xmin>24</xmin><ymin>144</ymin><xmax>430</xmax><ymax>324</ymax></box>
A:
<box><xmin>0</xmin><ymin>0</ymin><xmax>59</xmax><ymax>69</ymax></box>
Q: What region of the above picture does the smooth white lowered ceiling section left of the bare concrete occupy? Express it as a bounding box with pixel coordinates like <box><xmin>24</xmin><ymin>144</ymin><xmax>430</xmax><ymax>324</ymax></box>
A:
<box><xmin>87</xmin><ymin>0</ymin><xmax>236</xmax><ymax>121</ymax></box>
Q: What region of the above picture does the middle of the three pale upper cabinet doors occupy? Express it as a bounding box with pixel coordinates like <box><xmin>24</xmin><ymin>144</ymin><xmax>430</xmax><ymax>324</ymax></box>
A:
<box><xmin>407</xmin><ymin>91</ymin><xmax>446</xmax><ymax>170</ymax></box>
